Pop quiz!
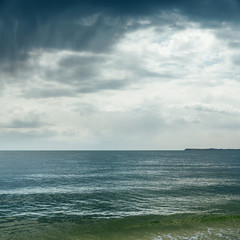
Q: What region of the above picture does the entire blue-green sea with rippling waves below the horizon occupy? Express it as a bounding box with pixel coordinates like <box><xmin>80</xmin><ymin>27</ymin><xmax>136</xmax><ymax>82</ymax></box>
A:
<box><xmin>0</xmin><ymin>150</ymin><xmax>240</xmax><ymax>240</ymax></box>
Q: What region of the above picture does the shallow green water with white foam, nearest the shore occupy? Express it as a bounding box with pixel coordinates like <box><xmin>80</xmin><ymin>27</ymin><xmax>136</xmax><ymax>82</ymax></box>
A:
<box><xmin>0</xmin><ymin>214</ymin><xmax>240</xmax><ymax>240</ymax></box>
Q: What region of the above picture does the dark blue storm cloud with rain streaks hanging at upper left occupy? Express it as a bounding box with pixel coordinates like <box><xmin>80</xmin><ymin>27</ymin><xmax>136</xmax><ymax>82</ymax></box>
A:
<box><xmin>0</xmin><ymin>0</ymin><xmax>240</xmax><ymax>61</ymax></box>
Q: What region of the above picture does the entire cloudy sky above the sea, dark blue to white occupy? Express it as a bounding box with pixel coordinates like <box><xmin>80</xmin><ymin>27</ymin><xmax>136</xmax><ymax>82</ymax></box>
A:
<box><xmin>0</xmin><ymin>0</ymin><xmax>240</xmax><ymax>150</ymax></box>
